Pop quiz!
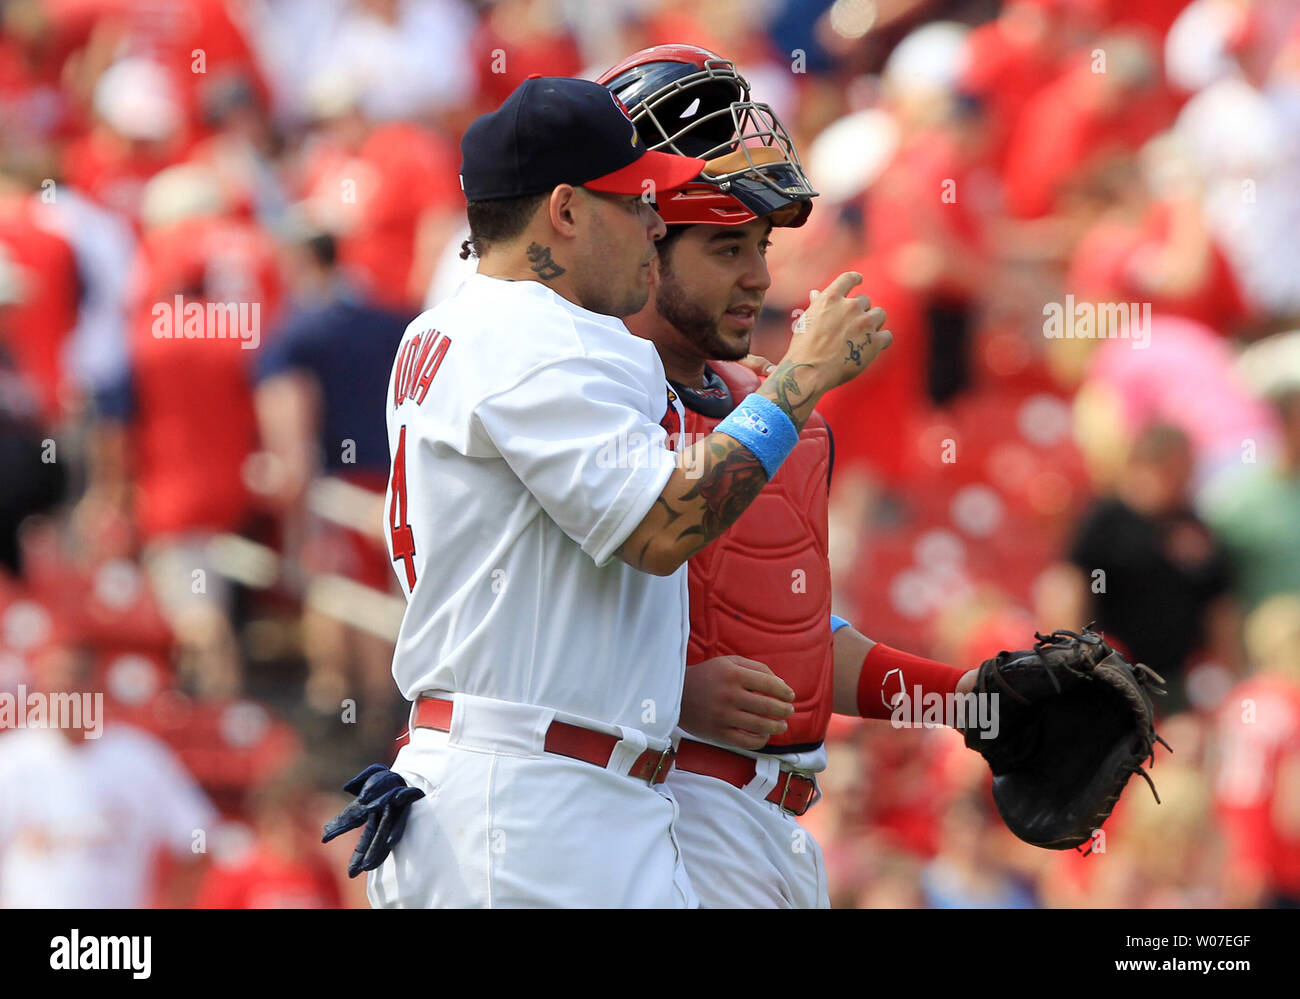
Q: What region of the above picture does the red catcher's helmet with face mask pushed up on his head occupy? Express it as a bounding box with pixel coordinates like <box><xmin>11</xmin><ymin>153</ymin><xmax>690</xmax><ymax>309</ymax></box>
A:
<box><xmin>595</xmin><ymin>46</ymin><xmax>816</xmax><ymax>226</ymax></box>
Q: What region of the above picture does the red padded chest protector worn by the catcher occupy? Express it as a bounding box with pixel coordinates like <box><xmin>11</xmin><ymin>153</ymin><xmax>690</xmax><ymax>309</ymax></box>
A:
<box><xmin>683</xmin><ymin>362</ymin><xmax>835</xmax><ymax>749</ymax></box>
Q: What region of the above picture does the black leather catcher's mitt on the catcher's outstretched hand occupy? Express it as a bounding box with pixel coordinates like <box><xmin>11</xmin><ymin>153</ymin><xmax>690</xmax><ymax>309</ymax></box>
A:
<box><xmin>965</xmin><ymin>624</ymin><xmax>1170</xmax><ymax>849</ymax></box>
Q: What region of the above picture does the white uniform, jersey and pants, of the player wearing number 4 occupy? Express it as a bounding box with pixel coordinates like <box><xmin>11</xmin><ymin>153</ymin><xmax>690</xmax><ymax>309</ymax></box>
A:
<box><xmin>367</xmin><ymin>274</ymin><xmax>697</xmax><ymax>908</ymax></box>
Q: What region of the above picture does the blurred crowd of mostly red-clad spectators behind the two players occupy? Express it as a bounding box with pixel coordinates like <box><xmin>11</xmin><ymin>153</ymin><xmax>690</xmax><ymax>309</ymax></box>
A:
<box><xmin>0</xmin><ymin>0</ymin><xmax>1300</xmax><ymax>908</ymax></box>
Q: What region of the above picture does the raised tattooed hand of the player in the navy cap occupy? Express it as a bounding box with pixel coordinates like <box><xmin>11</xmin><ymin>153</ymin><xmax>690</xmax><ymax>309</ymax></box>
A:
<box><xmin>783</xmin><ymin>271</ymin><xmax>893</xmax><ymax>392</ymax></box>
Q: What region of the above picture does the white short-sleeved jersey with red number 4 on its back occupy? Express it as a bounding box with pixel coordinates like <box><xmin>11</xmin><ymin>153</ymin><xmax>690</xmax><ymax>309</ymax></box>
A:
<box><xmin>385</xmin><ymin>273</ymin><xmax>689</xmax><ymax>739</ymax></box>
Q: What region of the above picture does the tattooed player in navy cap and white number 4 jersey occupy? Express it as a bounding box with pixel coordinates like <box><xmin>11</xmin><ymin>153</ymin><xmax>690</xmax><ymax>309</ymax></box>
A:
<box><xmin>325</xmin><ymin>78</ymin><xmax>891</xmax><ymax>907</ymax></box>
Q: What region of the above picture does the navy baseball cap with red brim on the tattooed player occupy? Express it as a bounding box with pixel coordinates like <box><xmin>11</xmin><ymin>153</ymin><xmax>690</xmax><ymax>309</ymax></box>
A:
<box><xmin>460</xmin><ymin>77</ymin><xmax>705</xmax><ymax>202</ymax></box>
